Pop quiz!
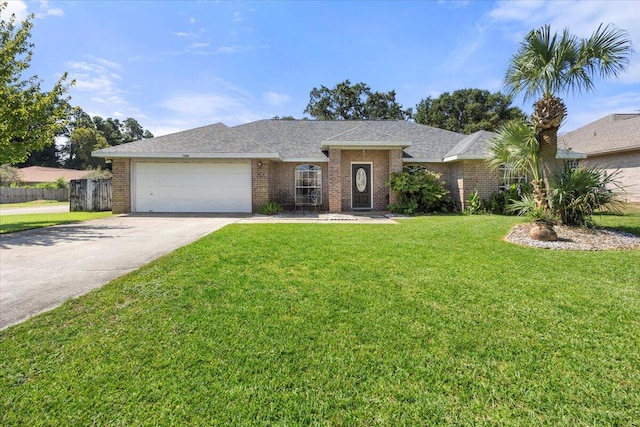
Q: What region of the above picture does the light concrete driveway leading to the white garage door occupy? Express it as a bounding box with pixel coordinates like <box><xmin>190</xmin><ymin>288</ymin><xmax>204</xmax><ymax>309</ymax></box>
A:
<box><xmin>0</xmin><ymin>215</ymin><xmax>243</xmax><ymax>329</ymax></box>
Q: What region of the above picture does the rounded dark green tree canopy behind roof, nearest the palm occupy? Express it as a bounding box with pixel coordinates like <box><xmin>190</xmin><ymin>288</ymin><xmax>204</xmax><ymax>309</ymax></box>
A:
<box><xmin>414</xmin><ymin>89</ymin><xmax>526</xmax><ymax>134</ymax></box>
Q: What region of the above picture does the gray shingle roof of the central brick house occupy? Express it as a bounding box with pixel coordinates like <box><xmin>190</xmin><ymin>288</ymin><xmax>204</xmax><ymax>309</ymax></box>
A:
<box><xmin>94</xmin><ymin>120</ymin><xmax>492</xmax><ymax>161</ymax></box>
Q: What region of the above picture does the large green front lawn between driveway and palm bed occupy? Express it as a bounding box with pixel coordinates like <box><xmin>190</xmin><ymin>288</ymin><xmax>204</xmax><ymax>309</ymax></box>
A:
<box><xmin>0</xmin><ymin>216</ymin><xmax>640</xmax><ymax>426</ymax></box>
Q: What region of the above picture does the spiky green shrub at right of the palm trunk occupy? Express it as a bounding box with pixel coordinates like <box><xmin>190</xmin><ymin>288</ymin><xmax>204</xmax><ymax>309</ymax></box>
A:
<box><xmin>549</xmin><ymin>166</ymin><xmax>621</xmax><ymax>227</ymax></box>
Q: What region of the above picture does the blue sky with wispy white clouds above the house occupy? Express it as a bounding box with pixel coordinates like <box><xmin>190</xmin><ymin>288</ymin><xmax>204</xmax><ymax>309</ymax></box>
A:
<box><xmin>9</xmin><ymin>0</ymin><xmax>640</xmax><ymax>136</ymax></box>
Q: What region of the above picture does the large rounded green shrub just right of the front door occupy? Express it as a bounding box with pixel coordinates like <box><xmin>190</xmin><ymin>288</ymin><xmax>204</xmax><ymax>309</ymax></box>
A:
<box><xmin>385</xmin><ymin>168</ymin><xmax>452</xmax><ymax>215</ymax></box>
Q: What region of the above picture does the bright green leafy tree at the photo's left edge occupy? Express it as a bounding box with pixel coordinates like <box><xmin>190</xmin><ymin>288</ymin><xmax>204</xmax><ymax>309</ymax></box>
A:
<box><xmin>0</xmin><ymin>3</ymin><xmax>68</xmax><ymax>164</ymax></box>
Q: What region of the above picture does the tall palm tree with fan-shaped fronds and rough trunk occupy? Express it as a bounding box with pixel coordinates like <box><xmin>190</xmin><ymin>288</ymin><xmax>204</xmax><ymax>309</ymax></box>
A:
<box><xmin>504</xmin><ymin>24</ymin><xmax>633</xmax><ymax>206</ymax></box>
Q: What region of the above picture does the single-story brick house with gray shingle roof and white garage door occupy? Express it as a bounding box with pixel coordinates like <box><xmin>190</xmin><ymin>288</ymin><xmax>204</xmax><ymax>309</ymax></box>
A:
<box><xmin>93</xmin><ymin>120</ymin><xmax>584</xmax><ymax>213</ymax></box>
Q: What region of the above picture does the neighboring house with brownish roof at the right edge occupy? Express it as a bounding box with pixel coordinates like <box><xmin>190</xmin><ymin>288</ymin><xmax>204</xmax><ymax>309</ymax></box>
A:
<box><xmin>558</xmin><ymin>114</ymin><xmax>640</xmax><ymax>202</ymax></box>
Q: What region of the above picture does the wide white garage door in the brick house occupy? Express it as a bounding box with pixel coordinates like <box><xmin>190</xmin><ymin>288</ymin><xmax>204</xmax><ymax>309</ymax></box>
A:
<box><xmin>133</xmin><ymin>162</ymin><xmax>251</xmax><ymax>212</ymax></box>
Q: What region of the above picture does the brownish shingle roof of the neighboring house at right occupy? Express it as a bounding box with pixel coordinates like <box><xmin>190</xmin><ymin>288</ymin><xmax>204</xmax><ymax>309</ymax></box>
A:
<box><xmin>558</xmin><ymin>114</ymin><xmax>640</xmax><ymax>155</ymax></box>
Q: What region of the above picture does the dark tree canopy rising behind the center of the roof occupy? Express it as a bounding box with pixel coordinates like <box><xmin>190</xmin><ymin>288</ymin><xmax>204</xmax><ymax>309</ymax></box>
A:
<box><xmin>304</xmin><ymin>80</ymin><xmax>411</xmax><ymax>120</ymax></box>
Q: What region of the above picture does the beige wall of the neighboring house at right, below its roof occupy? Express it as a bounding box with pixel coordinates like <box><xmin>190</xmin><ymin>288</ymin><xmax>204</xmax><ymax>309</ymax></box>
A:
<box><xmin>581</xmin><ymin>150</ymin><xmax>640</xmax><ymax>202</ymax></box>
